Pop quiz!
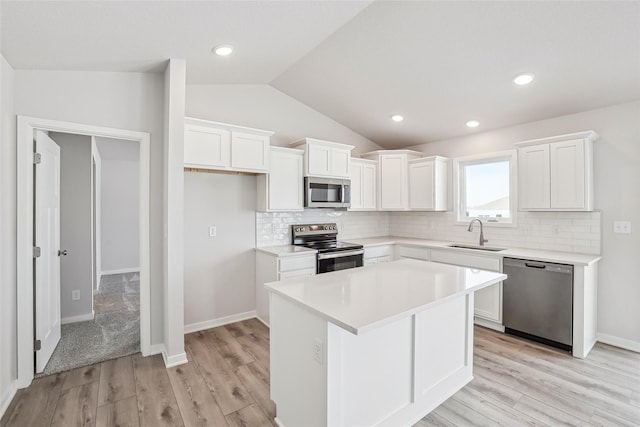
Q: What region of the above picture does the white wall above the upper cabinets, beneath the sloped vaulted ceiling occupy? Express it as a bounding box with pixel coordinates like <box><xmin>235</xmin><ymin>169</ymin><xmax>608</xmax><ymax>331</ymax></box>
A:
<box><xmin>186</xmin><ymin>84</ymin><xmax>380</xmax><ymax>154</ymax></box>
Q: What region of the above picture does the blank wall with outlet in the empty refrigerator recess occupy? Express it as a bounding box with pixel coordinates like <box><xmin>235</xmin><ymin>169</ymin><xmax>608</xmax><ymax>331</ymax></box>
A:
<box><xmin>184</xmin><ymin>172</ymin><xmax>256</xmax><ymax>329</ymax></box>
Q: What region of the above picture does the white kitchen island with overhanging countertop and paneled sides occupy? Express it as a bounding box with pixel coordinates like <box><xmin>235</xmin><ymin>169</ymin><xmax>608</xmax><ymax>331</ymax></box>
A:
<box><xmin>265</xmin><ymin>259</ymin><xmax>506</xmax><ymax>427</ymax></box>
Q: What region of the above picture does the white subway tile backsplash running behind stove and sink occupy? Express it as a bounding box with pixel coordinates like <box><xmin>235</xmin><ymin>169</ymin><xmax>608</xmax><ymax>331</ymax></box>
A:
<box><xmin>256</xmin><ymin>209</ymin><xmax>602</xmax><ymax>254</ymax></box>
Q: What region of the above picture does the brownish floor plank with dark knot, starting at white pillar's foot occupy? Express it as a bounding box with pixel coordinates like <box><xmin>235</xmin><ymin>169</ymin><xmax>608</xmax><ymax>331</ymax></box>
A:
<box><xmin>133</xmin><ymin>355</ymin><xmax>184</xmax><ymax>427</ymax></box>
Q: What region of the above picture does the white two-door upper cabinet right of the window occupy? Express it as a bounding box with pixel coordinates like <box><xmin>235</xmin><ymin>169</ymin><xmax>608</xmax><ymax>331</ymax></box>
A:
<box><xmin>516</xmin><ymin>131</ymin><xmax>598</xmax><ymax>211</ymax></box>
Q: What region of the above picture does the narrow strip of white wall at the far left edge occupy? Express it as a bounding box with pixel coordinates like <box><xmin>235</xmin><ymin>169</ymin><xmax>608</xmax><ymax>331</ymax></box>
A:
<box><xmin>0</xmin><ymin>56</ymin><xmax>18</xmax><ymax>417</ymax></box>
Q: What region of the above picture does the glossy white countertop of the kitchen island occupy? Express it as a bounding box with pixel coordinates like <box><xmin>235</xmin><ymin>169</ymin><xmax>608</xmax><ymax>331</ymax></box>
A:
<box><xmin>265</xmin><ymin>259</ymin><xmax>507</xmax><ymax>335</ymax></box>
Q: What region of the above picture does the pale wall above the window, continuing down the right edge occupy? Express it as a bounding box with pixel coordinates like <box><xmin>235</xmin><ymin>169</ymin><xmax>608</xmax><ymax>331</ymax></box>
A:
<box><xmin>408</xmin><ymin>101</ymin><xmax>640</xmax><ymax>351</ymax></box>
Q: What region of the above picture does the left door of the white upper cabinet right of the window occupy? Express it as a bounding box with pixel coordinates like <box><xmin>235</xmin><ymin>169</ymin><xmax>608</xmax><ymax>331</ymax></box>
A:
<box><xmin>518</xmin><ymin>144</ymin><xmax>551</xmax><ymax>210</ymax></box>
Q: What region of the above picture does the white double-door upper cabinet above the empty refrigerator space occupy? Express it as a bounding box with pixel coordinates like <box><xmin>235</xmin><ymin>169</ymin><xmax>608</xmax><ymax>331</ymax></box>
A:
<box><xmin>184</xmin><ymin>117</ymin><xmax>273</xmax><ymax>173</ymax></box>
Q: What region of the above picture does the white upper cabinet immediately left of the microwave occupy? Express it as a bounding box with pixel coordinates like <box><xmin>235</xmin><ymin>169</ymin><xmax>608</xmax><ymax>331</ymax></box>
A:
<box><xmin>257</xmin><ymin>147</ymin><xmax>304</xmax><ymax>212</ymax></box>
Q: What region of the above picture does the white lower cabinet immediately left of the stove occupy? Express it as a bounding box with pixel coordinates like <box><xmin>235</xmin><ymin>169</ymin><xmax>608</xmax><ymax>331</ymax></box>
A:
<box><xmin>256</xmin><ymin>251</ymin><xmax>316</xmax><ymax>325</ymax></box>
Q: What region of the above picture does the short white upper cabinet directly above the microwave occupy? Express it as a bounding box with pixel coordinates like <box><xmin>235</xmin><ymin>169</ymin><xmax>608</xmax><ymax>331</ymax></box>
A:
<box><xmin>290</xmin><ymin>138</ymin><xmax>353</xmax><ymax>179</ymax></box>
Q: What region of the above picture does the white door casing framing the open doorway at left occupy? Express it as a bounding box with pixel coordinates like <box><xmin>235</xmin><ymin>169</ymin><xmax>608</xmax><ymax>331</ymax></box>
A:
<box><xmin>16</xmin><ymin>116</ymin><xmax>151</xmax><ymax>388</ymax></box>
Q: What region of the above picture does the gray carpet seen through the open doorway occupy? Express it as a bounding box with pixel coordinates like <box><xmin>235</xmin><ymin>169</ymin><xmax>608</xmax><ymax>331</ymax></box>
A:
<box><xmin>37</xmin><ymin>273</ymin><xmax>140</xmax><ymax>376</ymax></box>
